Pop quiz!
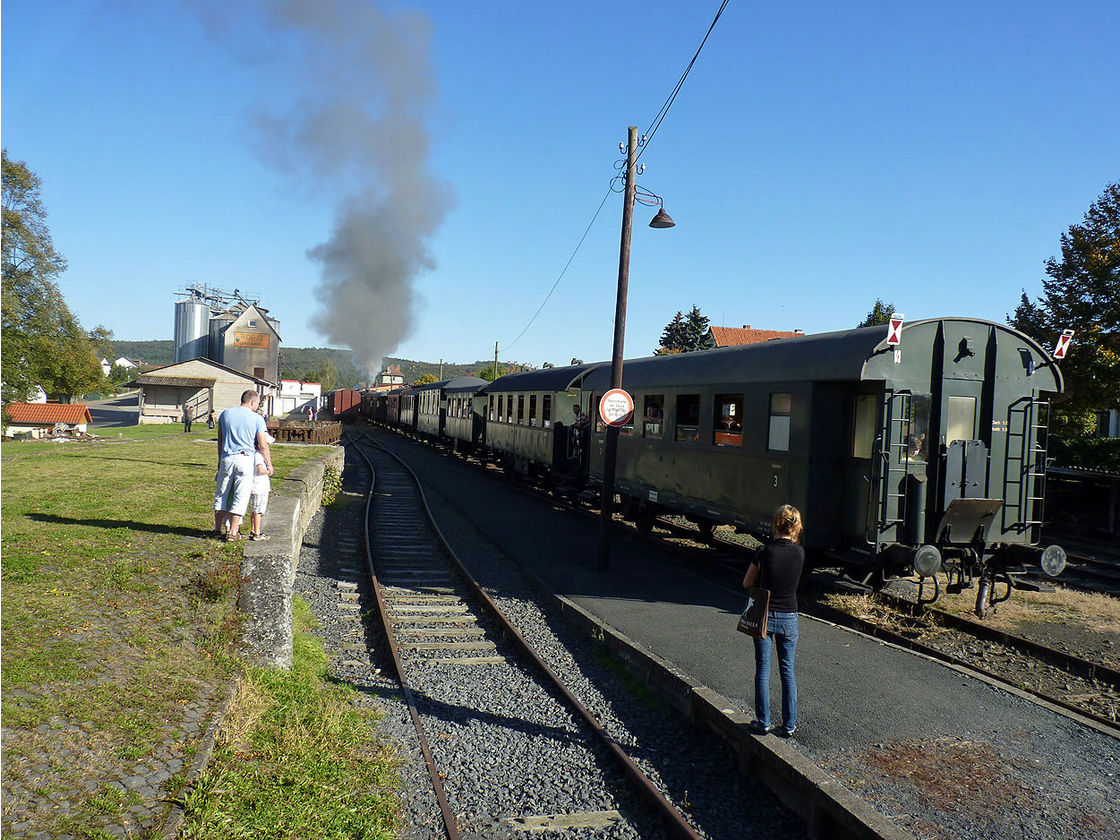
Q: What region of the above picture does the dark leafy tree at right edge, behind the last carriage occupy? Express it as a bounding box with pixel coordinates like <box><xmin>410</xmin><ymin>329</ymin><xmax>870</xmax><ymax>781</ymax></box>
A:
<box><xmin>1008</xmin><ymin>183</ymin><xmax>1120</xmax><ymax>423</ymax></box>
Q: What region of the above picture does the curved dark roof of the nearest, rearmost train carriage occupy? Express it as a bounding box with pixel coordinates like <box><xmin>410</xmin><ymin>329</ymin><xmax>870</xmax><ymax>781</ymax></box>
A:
<box><xmin>582</xmin><ymin>318</ymin><xmax>1062</xmax><ymax>392</ymax></box>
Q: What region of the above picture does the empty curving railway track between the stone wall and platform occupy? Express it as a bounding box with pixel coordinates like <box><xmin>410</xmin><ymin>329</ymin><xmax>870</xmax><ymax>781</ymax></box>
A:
<box><xmin>349</xmin><ymin>438</ymin><xmax>700</xmax><ymax>840</ymax></box>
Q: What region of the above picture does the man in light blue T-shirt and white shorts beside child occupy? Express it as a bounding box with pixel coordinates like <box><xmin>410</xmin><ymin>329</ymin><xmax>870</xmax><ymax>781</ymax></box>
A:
<box><xmin>214</xmin><ymin>391</ymin><xmax>272</xmax><ymax>541</ymax></box>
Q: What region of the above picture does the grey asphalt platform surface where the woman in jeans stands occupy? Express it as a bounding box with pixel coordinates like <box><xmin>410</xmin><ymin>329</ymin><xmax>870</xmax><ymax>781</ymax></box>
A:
<box><xmin>374</xmin><ymin>431</ymin><xmax>1120</xmax><ymax>838</ymax></box>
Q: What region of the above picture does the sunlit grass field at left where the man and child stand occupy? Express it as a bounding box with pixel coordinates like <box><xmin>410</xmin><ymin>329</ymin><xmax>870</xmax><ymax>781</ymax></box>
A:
<box><xmin>0</xmin><ymin>424</ymin><xmax>398</xmax><ymax>837</ymax></box>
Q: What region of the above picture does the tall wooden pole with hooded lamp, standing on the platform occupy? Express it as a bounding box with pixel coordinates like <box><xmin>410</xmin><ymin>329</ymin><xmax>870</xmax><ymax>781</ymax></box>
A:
<box><xmin>591</xmin><ymin>125</ymin><xmax>675</xmax><ymax>571</ymax></box>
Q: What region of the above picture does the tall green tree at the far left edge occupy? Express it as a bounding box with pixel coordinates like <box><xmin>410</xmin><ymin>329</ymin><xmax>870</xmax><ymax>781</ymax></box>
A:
<box><xmin>0</xmin><ymin>149</ymin><xmax>108</xmax><ymax>403</ymax></box>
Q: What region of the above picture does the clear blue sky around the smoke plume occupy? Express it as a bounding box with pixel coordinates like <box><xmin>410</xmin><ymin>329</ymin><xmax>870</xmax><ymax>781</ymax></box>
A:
<box><xmin>0</xmin><ymin>0</ymin><xmax>1120</xmax><ymax>374</ymax></box>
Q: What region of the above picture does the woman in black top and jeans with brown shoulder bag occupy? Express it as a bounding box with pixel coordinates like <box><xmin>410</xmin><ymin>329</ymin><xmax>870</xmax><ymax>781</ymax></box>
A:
<box><xmin>743</xmin><ymin>505</ymin><xmax>805</xmax><ymax>738</ymax></box>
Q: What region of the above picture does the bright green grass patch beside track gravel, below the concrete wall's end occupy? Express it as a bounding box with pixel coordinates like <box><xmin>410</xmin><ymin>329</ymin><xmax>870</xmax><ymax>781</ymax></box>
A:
<box><xmin>180</xmin><ymin>598</ymin><xmax>396</xmax><ymax>840</ymax></box>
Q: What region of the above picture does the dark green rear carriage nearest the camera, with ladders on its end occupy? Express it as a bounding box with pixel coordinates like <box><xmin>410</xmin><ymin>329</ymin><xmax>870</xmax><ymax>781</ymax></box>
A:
<box><xmin>582</xmin><ymin>318</ymin><xmax>1064</xmax><ymax>612</ymax></box>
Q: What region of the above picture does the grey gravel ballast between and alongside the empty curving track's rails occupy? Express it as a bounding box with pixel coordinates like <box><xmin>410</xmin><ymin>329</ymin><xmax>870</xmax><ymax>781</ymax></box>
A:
<box><xmin>296</xmin><ymin>443</ymin><xmax>804</xmax><ymax>838</ymax></box>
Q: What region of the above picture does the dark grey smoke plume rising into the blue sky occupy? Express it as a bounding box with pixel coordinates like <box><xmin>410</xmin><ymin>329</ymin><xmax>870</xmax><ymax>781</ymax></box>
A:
<box><xmin>199</xmin><ymin>0</ymin><xmax>454</xmax><ymax>373</ymax></box>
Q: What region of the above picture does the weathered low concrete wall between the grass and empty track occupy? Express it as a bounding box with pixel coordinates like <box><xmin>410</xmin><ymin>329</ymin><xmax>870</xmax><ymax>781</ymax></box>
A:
<box><xmin>237</xmin><ymin>447</ymin><xmax>345</xmax><ymax>669</ymax></box>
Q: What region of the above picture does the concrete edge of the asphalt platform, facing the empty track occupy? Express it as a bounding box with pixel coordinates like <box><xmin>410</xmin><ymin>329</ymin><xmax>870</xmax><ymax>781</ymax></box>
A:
<box><xmin>523</xmin><ymin>569</ymin><xmax>914</xmax><ymax>840</ymax></box>
